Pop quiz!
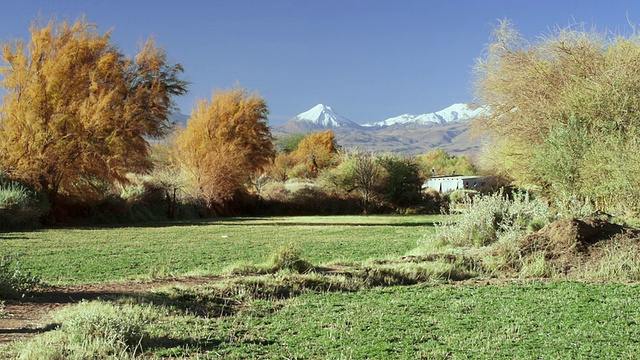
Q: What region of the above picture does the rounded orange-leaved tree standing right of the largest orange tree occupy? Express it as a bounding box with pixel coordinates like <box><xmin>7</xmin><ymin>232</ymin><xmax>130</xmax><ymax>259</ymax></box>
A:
<box><xmin>177</xmin><ymin>89</ymin><xmax>275</xmax><ymax>215</ymax></box>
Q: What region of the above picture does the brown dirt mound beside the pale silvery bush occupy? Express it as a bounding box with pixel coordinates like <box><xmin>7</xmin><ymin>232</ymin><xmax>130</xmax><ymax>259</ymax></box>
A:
<box><xmin>520</xmin><ymin>218</ymin><xmax>640</xmax><ymax>273</ymax></box>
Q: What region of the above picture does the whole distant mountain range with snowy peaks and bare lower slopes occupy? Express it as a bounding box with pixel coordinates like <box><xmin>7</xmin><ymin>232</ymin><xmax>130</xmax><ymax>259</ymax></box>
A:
<box><xmin>272</xmin><ymin>104</ymin><xmax>485</xmax><ymax>156</ymax></box>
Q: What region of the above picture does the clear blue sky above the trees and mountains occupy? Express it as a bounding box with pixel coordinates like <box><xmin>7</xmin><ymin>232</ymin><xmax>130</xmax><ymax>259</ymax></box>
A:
<box><xmin>0</xmin><ymin>0</ymin><xmax>640</xmax><ymax>125</ymax></box>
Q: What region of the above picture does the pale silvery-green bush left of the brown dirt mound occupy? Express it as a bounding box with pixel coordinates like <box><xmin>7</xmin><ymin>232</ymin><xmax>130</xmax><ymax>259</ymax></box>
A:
<box><xmin>424</xmin><ymin>190</ymin><xmax>552</xmax><ymax>247</ymax></box>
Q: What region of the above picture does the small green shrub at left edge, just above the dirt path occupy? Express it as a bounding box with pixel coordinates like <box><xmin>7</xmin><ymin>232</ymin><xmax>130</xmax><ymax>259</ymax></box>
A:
<box><xmin>0</xmin><ymin>254</ymin><xmax>40</xmax><ymax>299</ymax></box>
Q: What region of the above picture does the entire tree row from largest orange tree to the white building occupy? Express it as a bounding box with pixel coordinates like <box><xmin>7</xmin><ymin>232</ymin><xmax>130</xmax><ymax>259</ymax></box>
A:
<box><xmin>0</xmin><ymin>19</ymin><xmax>473</xmax><ymax>221</ymax></box>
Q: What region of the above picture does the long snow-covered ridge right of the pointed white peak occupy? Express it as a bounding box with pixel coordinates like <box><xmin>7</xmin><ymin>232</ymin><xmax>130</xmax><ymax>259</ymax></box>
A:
<box><xmin>362</xmin><ymin>104</ymin><xmax>484</xmax><ymax>127</ymax></box>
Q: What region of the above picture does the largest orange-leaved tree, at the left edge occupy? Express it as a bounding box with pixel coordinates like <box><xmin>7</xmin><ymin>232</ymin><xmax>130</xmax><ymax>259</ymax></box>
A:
<box><xmin>0</xmin><ymin>19</ymin><xmax>187</xmax><ymax>219</ymax></box>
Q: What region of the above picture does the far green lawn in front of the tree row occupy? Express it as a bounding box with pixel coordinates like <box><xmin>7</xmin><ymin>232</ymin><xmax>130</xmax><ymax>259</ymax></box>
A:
<box><xmin>0</xmin><ymin>216</ymin><xmax>440</xmax><ymax>284</ymax></box>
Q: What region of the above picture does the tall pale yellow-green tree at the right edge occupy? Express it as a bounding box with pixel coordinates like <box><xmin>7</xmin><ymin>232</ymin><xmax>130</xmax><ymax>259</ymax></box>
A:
<box><xmin>475</xmin><ymin>21</ymin><xmax>640</xmax><ymax>210</ymax></box>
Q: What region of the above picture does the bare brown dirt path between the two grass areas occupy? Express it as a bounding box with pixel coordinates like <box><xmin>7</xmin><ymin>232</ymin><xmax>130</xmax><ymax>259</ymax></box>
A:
<box><xmin>0</xmin><ymin>277</ymin><xmax>221</xmax><ymax>344</ymax></box>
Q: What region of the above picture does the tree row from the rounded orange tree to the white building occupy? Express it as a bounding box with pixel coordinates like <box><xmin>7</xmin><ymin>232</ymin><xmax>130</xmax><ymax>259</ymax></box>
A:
<box><xmin>170</xmin><ymin>89</ymin><xmax>474</xmax><ymax>214</ymax></box>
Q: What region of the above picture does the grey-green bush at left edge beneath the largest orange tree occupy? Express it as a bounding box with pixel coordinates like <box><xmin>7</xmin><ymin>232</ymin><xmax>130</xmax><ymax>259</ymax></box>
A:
<box><xmin>0</xmin><ymin>173</ymin><xmax>49</xmax><ymax>230</ymax></box>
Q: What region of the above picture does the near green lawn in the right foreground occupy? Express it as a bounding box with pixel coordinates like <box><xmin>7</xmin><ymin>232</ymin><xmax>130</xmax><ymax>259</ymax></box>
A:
<box><xmin>150</xmin><ymin>282</ymin><xmax>640</xmax><ymax>359</ymax></box>
